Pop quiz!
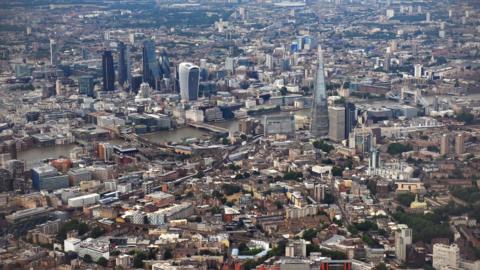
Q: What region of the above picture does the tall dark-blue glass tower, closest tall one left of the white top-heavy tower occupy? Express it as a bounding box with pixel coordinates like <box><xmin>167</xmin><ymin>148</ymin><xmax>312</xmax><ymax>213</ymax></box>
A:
<box><xmin>142</xmin><ymin>40</ymin><xmax>160</xmax><ymax>89</ymax></box>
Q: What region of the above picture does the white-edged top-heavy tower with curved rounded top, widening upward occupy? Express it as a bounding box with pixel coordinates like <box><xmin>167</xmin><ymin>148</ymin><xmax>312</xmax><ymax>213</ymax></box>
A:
<box><xmin>178</xmin><ymin>63</ymin><xmax>200</xmax><ymax>101</ymax></box>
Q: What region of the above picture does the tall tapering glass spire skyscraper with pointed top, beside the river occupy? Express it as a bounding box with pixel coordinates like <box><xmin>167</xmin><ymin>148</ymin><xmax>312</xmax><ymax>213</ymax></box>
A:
<box><xmin>310</xmin><ymin>48</ymin><xmax>328</xmax><ymax>137</ymax></box>
